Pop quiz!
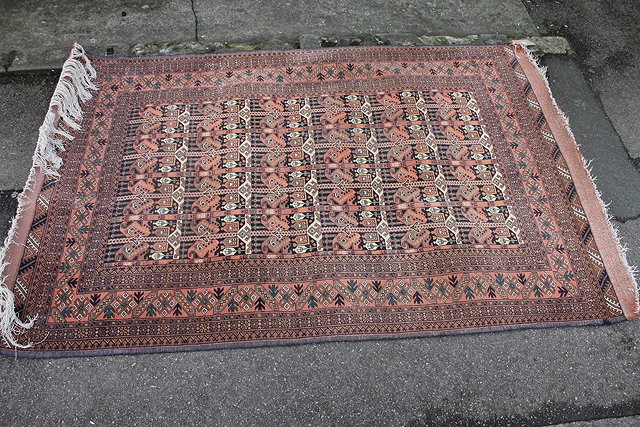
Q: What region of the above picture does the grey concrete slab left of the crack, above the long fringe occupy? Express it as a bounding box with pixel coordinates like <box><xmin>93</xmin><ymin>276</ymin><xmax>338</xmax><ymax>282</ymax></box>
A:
<box><xmin>0</xmin><ymin>0</ymin><xmax>195</xmax><ymax>70</ymax></box>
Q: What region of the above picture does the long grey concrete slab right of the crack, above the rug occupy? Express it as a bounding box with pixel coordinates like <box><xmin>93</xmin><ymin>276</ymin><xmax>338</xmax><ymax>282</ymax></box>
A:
<box><xmin>194</xmin><ymin>0</ymin><xmax>537</xmax><ymax>43</ymax></box>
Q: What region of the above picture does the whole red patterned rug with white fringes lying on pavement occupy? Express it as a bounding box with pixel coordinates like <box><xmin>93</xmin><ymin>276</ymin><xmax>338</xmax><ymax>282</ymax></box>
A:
<box><xmin>2</xmin><ymin>45</ymin><xmax>638</xmax><ymax>356</ymax></box>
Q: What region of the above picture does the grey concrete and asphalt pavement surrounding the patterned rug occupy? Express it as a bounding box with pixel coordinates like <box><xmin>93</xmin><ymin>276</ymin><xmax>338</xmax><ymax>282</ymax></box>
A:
<box><xmin>0</xmin><ymin>0</ymin><xmax>640</xmax><ymax>426</ymax></box>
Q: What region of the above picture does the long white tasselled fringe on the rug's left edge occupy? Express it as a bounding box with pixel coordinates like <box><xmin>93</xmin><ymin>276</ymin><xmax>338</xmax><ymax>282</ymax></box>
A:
<box><xmin>0</xmin><ymin>43</ymin><xmax>98</xmax><ymax>349</ymax></box>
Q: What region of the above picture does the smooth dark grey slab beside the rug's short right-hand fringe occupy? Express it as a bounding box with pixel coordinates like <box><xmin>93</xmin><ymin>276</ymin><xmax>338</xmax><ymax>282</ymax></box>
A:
<box><xmin>544</xmin><ymin>55</ymin><xmax>640</xmax><ymax>218</ymax></box>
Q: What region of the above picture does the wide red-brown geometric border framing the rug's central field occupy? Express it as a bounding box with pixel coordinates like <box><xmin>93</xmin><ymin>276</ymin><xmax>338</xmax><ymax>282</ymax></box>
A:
<box><xmin>6</xmin><ymin>46</ymin><xmax>622</xmax><ymax>354</ymax></box>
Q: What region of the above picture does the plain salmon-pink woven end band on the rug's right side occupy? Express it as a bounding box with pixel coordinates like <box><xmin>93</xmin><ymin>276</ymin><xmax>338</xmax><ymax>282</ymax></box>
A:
<box><xmin>513</xmin><ymin>43</ymin><xmax>640</xmax><ymax>320</ymax></box>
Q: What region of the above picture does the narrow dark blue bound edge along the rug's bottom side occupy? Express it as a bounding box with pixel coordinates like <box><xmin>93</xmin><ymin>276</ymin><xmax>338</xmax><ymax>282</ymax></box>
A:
<box><xmin>0</xmin><ymin>315</ymin><xmax>627</xmax><ymax>359</ymax></box>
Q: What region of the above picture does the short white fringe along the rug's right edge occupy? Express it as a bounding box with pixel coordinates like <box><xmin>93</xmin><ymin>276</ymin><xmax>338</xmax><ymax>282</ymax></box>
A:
<box><xmin>511</xmin><ymin>40</ymin><xmax>640</xmax><ymax>315</ymax></box>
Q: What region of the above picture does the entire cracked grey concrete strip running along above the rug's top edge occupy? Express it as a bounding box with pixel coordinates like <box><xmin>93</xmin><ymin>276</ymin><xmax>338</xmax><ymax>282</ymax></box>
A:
<box><xmin>0</xmin><ymin>0</ymin><xmax>537</xmax><ymax>70</ymax></box>
